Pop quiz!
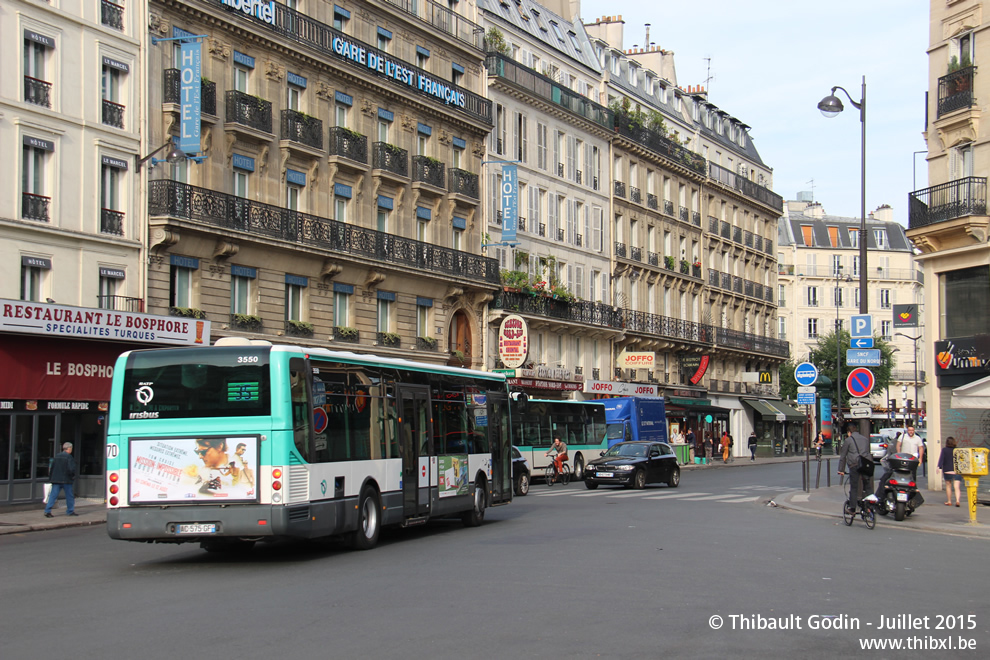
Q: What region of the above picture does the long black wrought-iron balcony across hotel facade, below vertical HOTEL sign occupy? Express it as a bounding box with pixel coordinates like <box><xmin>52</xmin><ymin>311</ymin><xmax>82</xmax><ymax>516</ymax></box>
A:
<box><xmin>148</xmin><ymin>179</ymin><xmax>499</xmax><ymax>286</ymax></box>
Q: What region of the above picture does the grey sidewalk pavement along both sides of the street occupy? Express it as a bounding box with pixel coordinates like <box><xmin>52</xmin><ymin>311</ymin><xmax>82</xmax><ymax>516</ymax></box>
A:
<box><xmin>0</xmin><ymin>456</ymin><xmax>990</xmax><ymax>539</ymax></box>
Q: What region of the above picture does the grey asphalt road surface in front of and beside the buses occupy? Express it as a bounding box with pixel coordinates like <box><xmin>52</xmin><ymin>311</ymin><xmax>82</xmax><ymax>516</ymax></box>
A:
<box><xmin>0</xmin><ymin>464</ymin><xmax>990</xmax><ymax>660</ymax></box>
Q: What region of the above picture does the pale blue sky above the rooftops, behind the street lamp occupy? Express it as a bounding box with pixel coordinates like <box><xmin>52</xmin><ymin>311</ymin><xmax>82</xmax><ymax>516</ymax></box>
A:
<box><xmin>580</xmin><ymin>0</ymin><xmax>929</xmax><ymax>226</ymax></box>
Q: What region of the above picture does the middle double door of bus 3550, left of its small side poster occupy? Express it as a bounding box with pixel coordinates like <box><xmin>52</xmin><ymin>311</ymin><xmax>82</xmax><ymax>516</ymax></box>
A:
<box><xmin>399</xmin><ymin>387</ymin><xmax>434</xmax><ymax>517</ymax></box>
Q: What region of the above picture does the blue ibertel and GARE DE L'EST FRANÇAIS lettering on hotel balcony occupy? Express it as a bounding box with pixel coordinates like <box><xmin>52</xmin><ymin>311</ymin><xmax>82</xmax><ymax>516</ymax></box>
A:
<box><xmin>216</xmin><ymin>0</ymin><xmax>466</xmax><ymax>108</ymax></box>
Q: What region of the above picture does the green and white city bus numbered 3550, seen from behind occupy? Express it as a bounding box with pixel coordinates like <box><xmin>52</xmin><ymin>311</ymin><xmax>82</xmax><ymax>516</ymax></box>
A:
<box><xmin>106</xmin><ymin>338</ymin><xmax>512</xmax><ymax>550</ymax></box>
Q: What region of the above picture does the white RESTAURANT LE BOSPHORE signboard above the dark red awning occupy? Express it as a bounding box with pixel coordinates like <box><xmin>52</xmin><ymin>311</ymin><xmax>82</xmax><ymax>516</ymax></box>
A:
<box><xmin>0</xmin><ymin>299</ymin><xmax>210</xmax><ymax>345</ymax></box>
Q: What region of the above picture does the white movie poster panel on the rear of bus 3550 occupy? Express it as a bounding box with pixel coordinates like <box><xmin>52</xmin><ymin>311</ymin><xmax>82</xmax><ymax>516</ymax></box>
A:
<box><xmin>130</xmin><ymin>436</ymin><xmax>258</xmax><ymax>503</ymax></box>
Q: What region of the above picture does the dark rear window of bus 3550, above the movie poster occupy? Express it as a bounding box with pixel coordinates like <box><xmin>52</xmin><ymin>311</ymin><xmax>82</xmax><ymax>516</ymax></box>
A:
<box><xmin>121</xmin><ymin>346</ymin><xmax>271</xmax><ymax>419</ymax></box>
